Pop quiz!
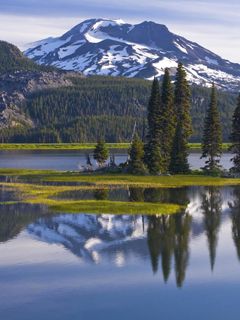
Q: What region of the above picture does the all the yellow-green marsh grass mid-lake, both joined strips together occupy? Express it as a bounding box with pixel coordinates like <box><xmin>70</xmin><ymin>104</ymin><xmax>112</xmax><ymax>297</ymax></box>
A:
<box><xmin>0</xmin><ymin>169</ymin><xmax>240</xmax><ymax>215</ymax></box>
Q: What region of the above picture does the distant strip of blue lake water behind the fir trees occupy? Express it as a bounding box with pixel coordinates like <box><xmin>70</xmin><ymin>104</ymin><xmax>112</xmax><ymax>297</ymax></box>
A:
<box><xmin>0</xmin><ymin>150</ymin><xmax>232</xmax><ymax>170</ymax></box>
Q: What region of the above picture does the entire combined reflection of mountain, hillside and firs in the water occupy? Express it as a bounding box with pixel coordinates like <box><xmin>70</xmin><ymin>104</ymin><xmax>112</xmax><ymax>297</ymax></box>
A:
<box><xmin>0</xmin><ymin>187</ymin><xmax>240</xmax><ymax>287</ymax></box>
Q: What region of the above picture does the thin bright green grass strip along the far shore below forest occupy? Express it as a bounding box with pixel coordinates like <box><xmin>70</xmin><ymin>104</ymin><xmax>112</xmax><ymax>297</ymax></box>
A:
<box><xmin>0</xmin><ymin>143</ymin><xmax>230</xmax><ymax>151</ymax></box>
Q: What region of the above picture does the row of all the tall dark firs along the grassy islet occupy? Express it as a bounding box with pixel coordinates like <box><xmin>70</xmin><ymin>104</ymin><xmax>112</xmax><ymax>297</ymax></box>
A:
<box><xmin>129</xmin><ymin>63</ymin><xmax>240</xmax><ymax>175</ymax></box>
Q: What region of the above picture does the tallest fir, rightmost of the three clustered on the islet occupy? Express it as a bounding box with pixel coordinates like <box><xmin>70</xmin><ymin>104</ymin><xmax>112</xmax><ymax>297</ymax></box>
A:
<box><xmin>169</xmin><ymin>63</ymin><xmax>192</xmax><ymax>173</ymax></box>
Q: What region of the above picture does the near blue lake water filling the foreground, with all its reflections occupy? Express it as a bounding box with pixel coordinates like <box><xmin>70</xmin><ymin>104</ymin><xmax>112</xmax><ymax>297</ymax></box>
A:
<box><xmin>0</xmin><ymin>185</ymin><xmax>240</xmax><ymax>320</ymax></box>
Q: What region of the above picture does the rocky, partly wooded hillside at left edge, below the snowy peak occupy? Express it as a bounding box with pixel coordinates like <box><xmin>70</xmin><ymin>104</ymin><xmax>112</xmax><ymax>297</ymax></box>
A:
<box><xmin>0</xmin><ymin>41</ymin><xmax>81</xmax><ymax>131</ymax></box>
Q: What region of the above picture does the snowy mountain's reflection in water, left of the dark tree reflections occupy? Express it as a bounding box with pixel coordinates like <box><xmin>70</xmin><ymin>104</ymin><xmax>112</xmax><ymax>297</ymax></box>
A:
<box><xmin>27</xmin><ymin>214</ymin><xmax>147</xmax><ymax>263</ymax></box>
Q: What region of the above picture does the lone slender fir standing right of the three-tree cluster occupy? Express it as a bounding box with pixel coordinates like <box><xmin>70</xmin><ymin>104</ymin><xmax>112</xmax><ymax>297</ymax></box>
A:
<box><xmin>202</xmin><ymin>84</ymin><xmax>222</xmax><ymax>174</ymax></box>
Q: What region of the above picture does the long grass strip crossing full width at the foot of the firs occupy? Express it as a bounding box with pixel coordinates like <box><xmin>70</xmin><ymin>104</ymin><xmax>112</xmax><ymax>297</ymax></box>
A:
<box><xmin>0</xmin><ymin>169</ymin><xmax>240</xmax><ymax>188</ymax></box>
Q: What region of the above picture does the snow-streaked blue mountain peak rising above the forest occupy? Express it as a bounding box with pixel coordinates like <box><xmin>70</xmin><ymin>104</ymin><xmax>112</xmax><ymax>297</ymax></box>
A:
<box><xmin>25</xmin><ymin>19</ymin><xmax>240</xmax><ymax>90</ymax></box>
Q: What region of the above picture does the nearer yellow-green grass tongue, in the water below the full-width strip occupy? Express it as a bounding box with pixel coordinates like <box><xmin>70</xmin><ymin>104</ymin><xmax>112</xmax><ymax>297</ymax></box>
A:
<box><xmin>0</xmin><ymin>183</ymin><xmax>183</xmax><ymax>215</ymax></box>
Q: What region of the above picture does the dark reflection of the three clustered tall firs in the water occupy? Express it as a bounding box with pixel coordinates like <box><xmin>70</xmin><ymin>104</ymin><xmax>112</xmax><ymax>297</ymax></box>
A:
<box><xmin>147</xmin><ymin>188</ymin><xmax>192</xmax><ymax>287</ymax></box>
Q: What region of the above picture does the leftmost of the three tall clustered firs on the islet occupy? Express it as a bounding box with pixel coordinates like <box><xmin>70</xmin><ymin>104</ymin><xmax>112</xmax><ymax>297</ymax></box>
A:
<box><xmin>144</xmin><ymin>78</ymin><xmax>162</xmax><ymax>174</ymax></box>
